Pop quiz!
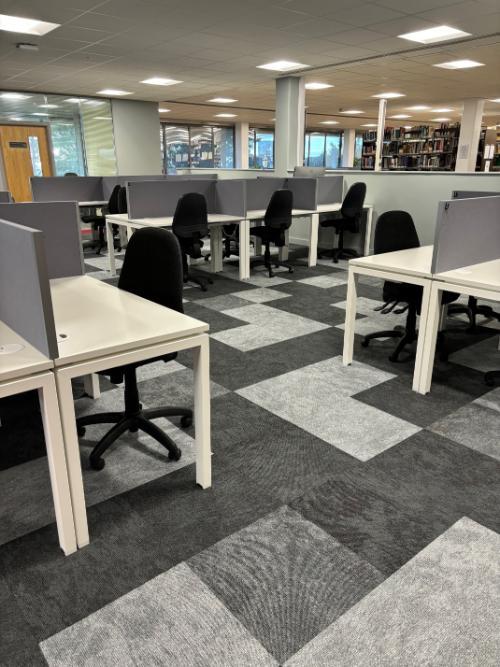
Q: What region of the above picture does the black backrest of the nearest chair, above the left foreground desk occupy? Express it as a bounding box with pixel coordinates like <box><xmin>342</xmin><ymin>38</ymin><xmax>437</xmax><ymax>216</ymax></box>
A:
<box><xmin>118</xmin><ymin>227</ymin><xmax>184</xmax><ymax>313</ymax></box>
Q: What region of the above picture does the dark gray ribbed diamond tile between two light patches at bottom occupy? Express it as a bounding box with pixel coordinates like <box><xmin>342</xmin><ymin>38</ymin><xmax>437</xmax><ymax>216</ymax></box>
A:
<box><xmin>189</xmin><ymin>507</ymin><xmax>383</xmax><ymax>663</ymax></box>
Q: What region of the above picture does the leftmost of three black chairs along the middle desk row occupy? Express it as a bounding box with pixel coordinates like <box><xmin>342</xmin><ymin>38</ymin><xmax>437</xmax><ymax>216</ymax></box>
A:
<box><xmin>172</xmin><ymin>192</ymin><xmax>213</xmax><ymax>292</ymax></box>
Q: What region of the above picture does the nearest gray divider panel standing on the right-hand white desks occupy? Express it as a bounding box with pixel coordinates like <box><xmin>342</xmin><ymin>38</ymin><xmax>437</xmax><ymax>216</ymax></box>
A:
<box><xmin>432</xmin><ymin>195</ymin><xmax>500</xmax><ymax>273</ymax></box>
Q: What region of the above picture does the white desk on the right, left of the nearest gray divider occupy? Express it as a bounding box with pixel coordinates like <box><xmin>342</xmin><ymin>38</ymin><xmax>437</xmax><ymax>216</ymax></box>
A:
<box><xmin>343</xmin><ymin>246</ymin><xmax>433</xmax><ymax>393</ymax></box>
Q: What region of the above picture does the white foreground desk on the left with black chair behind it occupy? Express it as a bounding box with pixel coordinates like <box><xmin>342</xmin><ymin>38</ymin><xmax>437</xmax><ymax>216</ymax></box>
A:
<box><xmin>51</xmin><ymin>276</ymin><xmax>211</xmax><ymax>547</ymax></box>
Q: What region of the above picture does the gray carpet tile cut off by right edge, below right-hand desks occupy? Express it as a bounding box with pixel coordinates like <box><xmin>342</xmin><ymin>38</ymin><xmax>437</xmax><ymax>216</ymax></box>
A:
<box><xmin>429</xmin><ymin>402</ymin><xmax>500</xmax><ymax>460</ymax></box>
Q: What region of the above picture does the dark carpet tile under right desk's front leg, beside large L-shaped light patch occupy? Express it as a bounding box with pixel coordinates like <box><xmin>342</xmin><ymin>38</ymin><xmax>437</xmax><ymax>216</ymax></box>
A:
<box><xmin>353</xmin><ymin>370</ymin><xmax>484</xmax><ymax>427</ymax></box>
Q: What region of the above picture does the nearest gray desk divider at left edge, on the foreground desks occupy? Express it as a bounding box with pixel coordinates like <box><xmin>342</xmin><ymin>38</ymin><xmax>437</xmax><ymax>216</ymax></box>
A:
<box><xmin>0</xmin><ymin>219</ymin><xmax>59</xmax><ymax>359</ymax></box>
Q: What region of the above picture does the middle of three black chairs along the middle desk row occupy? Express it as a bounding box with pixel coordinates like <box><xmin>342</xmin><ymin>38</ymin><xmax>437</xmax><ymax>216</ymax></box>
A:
<box><xmin>250</xmin><ymin>190</ymin><xmax>293</xmax><ymax>278</ymax></box>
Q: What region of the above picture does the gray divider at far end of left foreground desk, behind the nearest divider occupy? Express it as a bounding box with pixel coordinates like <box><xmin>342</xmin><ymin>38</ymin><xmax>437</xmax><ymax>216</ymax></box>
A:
<box><xmin>0</xmin><ymin>201</ymin><xmax>85</xmax><ymax>278</ymax></box>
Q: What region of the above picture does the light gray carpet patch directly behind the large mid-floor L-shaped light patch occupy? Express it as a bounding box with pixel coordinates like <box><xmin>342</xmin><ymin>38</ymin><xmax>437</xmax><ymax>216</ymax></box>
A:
<box><xmin>212</xmin><ymin>304</ymin><xmax>328</xmax><ymax>352</ymax></box>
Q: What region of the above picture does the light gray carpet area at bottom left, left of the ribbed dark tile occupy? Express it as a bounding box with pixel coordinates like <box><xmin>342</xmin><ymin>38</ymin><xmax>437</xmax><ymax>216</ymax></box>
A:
<box><xmin>40</xmin><ymin>564</ymin><xmax>277</xmax><ymax>667</ymax></box>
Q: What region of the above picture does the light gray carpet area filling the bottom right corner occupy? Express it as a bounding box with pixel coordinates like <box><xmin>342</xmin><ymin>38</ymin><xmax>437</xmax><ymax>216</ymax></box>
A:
<box><xmin>286</xmin><ymin>518</ymin><xmax>500</xmax><ymax>667</ymax></box>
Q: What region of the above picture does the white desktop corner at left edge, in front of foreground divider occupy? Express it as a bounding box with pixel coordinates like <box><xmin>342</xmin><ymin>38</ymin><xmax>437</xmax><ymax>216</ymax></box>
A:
<box><xmin>0</xmin><ymin>321</ymin><xmax>54</xmax><ymax>382</ymax></box>
